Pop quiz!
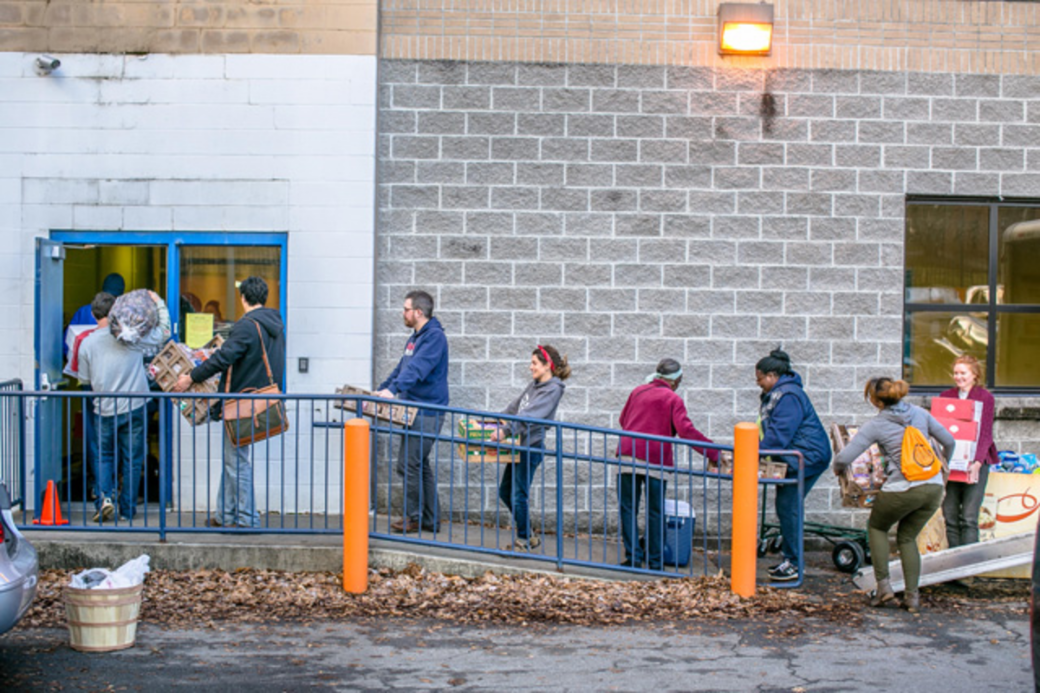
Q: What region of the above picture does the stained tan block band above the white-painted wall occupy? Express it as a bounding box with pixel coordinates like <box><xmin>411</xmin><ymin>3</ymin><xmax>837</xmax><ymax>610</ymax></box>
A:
<box><xmin>0</xmin><ymin>0</ymin><xmax>378</xmax><ymax>55</ymax></box>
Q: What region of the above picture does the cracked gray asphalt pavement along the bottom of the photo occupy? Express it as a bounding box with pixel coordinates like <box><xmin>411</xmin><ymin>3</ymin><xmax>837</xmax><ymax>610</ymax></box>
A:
<box><xmin>0</xmin><ymin>602</ymin><xmax>1033</xmax><ymax>693</ymax></box>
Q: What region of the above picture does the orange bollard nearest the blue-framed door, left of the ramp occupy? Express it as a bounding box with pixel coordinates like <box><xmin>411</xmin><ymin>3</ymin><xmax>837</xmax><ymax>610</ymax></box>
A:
<box><xmin>343</xmin><ymin>418</ymin><xmax>369</xmax><ymax>594</ymax></box>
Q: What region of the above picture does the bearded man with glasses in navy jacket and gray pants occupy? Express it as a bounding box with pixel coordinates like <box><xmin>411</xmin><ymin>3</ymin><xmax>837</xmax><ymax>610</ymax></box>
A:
<box><xmin>376</xmin><ymin>291</ymin><xmax>448</xmax><ymax>534</ymax></box>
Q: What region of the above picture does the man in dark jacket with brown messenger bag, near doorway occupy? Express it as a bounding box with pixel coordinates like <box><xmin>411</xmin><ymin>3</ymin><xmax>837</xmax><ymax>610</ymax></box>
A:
<box><xmin>174</xmin><ymin>277</ymin><xmax>289</xmax><ymax>528</ymax></box>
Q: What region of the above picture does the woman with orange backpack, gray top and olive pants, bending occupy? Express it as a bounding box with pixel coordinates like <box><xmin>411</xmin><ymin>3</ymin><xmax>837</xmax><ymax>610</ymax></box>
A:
<box><xmin>834</xmin><ymin>378</ymin><xmax>954</xmax><ymax>614</ymax></box>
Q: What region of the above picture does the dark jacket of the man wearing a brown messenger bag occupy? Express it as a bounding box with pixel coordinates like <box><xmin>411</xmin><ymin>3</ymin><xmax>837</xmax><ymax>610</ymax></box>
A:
<box><xmin>191</xmin><ymin>308</ymin><xmax>285</xmax><ymax>392</ymax></box>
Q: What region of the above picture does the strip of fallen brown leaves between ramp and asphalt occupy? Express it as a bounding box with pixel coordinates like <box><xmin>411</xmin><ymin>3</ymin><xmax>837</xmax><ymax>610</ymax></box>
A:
<box><xmin>21</xmin><ymin>565</ymin><xmax>1028</xmax><ymax>627</ymax></box>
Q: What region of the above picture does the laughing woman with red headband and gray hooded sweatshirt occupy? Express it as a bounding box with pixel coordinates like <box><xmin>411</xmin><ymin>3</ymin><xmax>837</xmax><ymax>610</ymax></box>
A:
<box><xmin>491</xmin><ymin>344</ymin><xmax>571</xmax><ymax>551</ymax></box>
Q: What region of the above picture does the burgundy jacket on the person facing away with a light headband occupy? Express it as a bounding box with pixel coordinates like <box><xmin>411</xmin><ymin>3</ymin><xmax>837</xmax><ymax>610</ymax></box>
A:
<box><xmin>618</xmin><ymin>378</ymin><xmax>719</xmax><ymax>467</ymax></box>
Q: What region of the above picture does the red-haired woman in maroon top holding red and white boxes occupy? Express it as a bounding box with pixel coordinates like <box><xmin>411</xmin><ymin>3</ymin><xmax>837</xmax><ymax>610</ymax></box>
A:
<box><xmin>940</xmin><ymin>355</ymin><xmax>998</xmax><ymax>548</ymax></box>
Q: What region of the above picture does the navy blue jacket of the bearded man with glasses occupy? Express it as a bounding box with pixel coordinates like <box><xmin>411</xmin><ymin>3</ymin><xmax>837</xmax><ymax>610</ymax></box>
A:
<box><xmin>376</xmin><ymin>317</ymin><xmax>448</xmax><ymax>406</ymax></box>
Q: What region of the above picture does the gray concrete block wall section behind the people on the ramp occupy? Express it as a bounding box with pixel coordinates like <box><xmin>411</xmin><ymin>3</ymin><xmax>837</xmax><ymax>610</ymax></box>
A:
<box><xmin>374</xmin><ymin>60</ymin><xmax>1040</xmax><ymax>521</ymax></box>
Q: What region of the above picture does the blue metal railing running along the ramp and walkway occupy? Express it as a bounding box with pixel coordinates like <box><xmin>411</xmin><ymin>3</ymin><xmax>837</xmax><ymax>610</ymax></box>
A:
<box><xmin>2</xmin><ymin>390</ymin><xmax>804</xmax><ymax>587</ymax></box>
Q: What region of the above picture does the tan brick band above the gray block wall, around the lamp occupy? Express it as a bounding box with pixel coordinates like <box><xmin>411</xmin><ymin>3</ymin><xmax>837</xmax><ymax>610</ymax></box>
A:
<box><xmin>380</xmin><ymin>0</ymin><xmax>1040</xmax><ymax>75</ymax></box>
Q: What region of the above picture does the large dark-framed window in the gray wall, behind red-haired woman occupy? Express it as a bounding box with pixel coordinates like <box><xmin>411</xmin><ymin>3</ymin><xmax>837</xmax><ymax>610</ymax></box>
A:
<box><xmin>903</xmin><ymin>201</ymin><xmax>1040</xmax><ymax>392</ymax></box>
